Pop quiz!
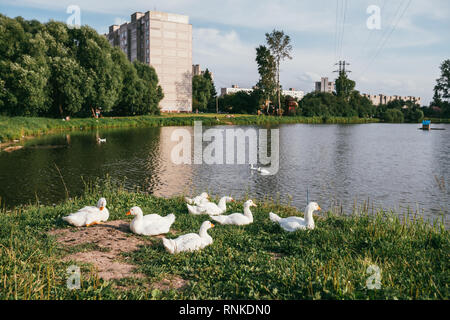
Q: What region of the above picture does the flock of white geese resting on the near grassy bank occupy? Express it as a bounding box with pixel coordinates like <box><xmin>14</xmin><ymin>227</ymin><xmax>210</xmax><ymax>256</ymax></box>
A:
<box><xmin>63</xmin><ymin>192</ymin><xmax>321</xmax><ymax>254</ymax></box>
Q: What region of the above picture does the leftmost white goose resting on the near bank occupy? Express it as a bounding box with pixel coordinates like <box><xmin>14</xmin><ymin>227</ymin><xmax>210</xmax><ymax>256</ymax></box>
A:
<box><xmin>62</xmin><ymin>198</ymin><xmax>109</xmax><ymax>227</ymax></box>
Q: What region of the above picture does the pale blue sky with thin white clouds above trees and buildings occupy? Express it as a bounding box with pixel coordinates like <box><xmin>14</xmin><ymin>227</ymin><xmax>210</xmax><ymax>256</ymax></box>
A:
<box><xmin>0</xmin><ymin>0</ymin><xmax>450</xmax><ymax>105</ymax></box>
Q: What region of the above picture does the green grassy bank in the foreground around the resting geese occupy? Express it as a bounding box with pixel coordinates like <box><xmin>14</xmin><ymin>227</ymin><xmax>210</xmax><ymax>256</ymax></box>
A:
<box><xmin>0</xmin><ymin>182</ymin><xmax>450</xmax><ymax>299</ymax></box>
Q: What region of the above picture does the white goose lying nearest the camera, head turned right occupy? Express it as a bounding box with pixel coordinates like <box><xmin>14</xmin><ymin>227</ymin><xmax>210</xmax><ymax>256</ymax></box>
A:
<box><xmin>162</xmin><ymin>221</ymin><xmax>214</xmax><ymax>254</ymax></box>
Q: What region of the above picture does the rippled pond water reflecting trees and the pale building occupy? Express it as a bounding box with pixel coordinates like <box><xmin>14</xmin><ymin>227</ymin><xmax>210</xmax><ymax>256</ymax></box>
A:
<box><xmin>0</xmin><ymin>124</ymin><xmax>450</xmax><ymax>225</ymax></box>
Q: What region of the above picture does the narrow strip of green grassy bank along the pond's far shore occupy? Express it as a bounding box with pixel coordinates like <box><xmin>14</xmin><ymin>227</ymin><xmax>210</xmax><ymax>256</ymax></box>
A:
<box><xmin>0</xmin><ymin>114</ymin><xmax>378</xmax><ymax>142</ymax></box>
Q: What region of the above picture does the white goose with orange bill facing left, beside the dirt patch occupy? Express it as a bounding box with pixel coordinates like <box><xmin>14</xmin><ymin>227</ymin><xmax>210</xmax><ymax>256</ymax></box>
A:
<box><xmin>127</xmin><ymin>207</ymin><xmax>175</xmax><ymax>236</ymax></box>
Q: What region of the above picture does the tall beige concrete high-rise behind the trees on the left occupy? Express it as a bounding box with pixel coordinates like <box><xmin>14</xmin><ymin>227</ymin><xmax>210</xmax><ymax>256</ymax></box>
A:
<box><xmin>106</xmin><ymin>11</ymin><xmax>192</xmax><ymax>112</ymax></box>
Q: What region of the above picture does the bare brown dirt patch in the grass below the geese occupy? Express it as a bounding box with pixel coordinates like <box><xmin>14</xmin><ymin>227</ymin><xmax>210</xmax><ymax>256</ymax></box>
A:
<box><xmin>49</xmin><ymin>220</ymin><xmax>145</xmax><ymax>280</ymax></box>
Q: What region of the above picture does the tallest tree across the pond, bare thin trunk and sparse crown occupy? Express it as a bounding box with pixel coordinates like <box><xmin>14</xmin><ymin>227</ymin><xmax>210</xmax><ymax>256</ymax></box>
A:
<box><xmin>266</xmin><ymin>29</ymin><xmax>292</xmax><ymax>107</ymax></box>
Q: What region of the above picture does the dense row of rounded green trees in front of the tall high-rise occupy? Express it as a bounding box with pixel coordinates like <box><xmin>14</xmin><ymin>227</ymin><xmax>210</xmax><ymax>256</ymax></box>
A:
<box><xmin>0</xmin><ymin>14</ymin><xmax>164</xmax><ymax>118</ymax></box>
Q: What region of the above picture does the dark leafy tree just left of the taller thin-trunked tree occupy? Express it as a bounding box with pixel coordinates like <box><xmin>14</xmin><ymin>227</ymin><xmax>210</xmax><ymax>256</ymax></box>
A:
<box><xmin>256</xmin><ymin>46</ymin><xmax>277</xmax><ymax>107</ymax></box>
